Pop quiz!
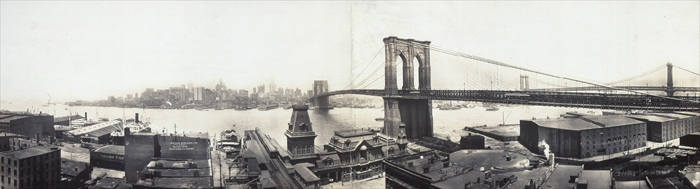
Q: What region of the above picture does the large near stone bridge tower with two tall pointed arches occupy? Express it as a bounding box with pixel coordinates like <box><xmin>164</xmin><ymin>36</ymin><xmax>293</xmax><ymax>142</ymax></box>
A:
<box><xmin>383</xmin><ymin>36</ymin><xmax>433</xmax><ymax>139</ymax></box>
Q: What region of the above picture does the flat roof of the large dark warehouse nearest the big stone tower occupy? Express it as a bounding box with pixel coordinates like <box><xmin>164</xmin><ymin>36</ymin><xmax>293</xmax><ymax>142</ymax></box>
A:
<box><xmin>521</xmin><ymin>115</ymin><xmax>644</xmax><ymax>131</ymax></box>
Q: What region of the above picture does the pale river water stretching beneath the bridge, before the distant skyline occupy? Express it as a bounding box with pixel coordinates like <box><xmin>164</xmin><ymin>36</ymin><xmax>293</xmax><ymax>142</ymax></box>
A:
<box><xmin>0</xmin><ymin>102</ymin><xmax>600</xmax><ymax>146</ymax></box>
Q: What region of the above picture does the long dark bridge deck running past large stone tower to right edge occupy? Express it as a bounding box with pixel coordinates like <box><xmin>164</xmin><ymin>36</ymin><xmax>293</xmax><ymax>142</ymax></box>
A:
<box><xmin>312</xmin><ymin>89</ymin><xmax>700</xmax><ymax>111</ymax></box>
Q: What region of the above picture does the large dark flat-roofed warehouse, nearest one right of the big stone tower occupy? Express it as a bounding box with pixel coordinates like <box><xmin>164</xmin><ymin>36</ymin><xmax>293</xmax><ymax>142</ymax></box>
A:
<box><xmin>519</xmin><ymin>115</ymin><xmax>647</xmax><ymax>158</ymax></box>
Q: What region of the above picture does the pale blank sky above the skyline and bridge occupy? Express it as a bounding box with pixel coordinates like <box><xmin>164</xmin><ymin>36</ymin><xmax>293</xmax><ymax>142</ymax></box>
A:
<box><xmin>0</xmin><ymin>1</ymin><xmax>700</xmax><ymax>101</ymax></box>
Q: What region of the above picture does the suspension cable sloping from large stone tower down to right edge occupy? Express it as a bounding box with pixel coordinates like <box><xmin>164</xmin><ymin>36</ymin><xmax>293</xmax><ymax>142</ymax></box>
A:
<box><xmin>398</xmin><ymin>41</ymin><xmax>700</xmax><ymax>104</ymax></box>
